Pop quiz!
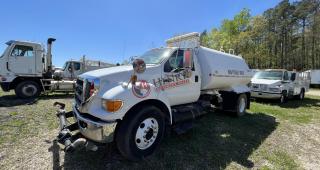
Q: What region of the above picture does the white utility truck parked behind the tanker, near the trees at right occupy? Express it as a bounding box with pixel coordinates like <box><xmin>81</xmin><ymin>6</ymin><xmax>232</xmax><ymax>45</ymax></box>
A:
<box><xmin>251</xmin><ymin>69</ymin><xmax>310</xmax><ymax>103</ymax></box>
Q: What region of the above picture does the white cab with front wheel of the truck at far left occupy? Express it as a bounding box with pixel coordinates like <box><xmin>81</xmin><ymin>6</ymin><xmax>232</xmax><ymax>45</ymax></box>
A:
<box><xmin>0</xmin><ymin>40</ymin><xmax>47</xmax><ymax>97</ymax></box>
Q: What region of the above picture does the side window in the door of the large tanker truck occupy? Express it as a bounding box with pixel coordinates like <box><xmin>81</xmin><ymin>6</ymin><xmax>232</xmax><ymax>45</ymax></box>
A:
<box><xmin>164</xmin><ymin>50</ymin><xmax>184</xmax><ymax>72</ymax></box>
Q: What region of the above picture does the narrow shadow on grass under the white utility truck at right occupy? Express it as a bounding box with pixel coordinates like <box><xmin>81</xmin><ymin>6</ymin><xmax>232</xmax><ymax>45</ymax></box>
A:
<box><xmin>255</xmin><ymin>96</ymin><xmax>320</xmax><ymax>109</ymax></box>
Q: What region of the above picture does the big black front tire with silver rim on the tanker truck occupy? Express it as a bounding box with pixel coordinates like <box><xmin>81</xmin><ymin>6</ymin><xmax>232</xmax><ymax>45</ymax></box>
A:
<box><xmin>116</xmin><ymin>106</ymin><xmax>165</xmax><ymax>161</ymax></box>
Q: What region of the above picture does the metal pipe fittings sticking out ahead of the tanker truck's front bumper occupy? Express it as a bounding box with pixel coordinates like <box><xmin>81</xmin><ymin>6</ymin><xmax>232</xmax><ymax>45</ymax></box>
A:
<box><xmin>53</xmin><ymin>102</ymin><xmax>98</xmax><ymax>152</ymax></box>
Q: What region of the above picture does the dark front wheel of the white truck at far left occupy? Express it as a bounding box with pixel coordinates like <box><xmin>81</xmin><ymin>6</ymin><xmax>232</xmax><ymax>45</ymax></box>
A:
<box><xmin>14</xmin><ymin>81</ymin><xmax>41</xmax><ymax>99</ymax></box>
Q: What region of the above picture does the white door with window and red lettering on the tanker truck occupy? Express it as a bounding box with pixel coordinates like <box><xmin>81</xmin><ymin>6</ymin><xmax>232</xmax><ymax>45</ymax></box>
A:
<box><xmin>161</xmin><ymin>49</ymin><xmax>200</xmax><ymax>106</ymax></box>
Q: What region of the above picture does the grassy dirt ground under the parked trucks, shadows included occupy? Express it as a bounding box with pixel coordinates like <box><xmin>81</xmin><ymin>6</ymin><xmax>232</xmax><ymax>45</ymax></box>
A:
<box><xmin>0</xmin><ymin>91</ymin><xmax>320</xmax><ymax>169</ymax></box>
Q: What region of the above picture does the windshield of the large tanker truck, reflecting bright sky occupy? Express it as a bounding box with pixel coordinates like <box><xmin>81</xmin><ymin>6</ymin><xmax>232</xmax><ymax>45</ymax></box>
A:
<box><xmin>139</xmin><ymin>48</ymin><xmax>172</xmax><ymax>64</ymax></box>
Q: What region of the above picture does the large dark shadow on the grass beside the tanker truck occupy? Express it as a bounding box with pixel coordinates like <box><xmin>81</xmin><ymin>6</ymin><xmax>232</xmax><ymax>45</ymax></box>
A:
<box><xmin>50</xmin><ymin>113</ymin><xmax>278</xmax><ymax>169</ymax></box>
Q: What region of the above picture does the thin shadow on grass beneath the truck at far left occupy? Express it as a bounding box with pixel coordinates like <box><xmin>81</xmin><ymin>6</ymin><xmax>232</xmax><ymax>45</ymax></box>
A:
<box><xmin>0</xmin><ymin>93</ymin><xmax>73</xmax><ymax>107</ymax></box>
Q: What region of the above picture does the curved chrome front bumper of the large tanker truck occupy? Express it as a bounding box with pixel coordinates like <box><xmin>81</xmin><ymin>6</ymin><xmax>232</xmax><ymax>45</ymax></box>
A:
<box><xmin>73</xmin><ymin>106</ymin><xmax>117</xmax><ymax>143</ymax></box>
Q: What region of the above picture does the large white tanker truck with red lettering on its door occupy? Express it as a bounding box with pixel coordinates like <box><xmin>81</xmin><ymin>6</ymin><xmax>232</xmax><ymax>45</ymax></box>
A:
<box><xmin>56</xmin><ymin>33</ymin><xmax>252</xmax><ymax>160</ymax></box>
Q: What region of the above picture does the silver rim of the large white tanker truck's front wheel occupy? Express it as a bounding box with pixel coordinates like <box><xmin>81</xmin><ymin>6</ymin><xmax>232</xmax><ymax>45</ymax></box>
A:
<box><xmin>135</xmin><ymin>118</ymin><xmax>159</xmax><ymax>150</ymax></box>
